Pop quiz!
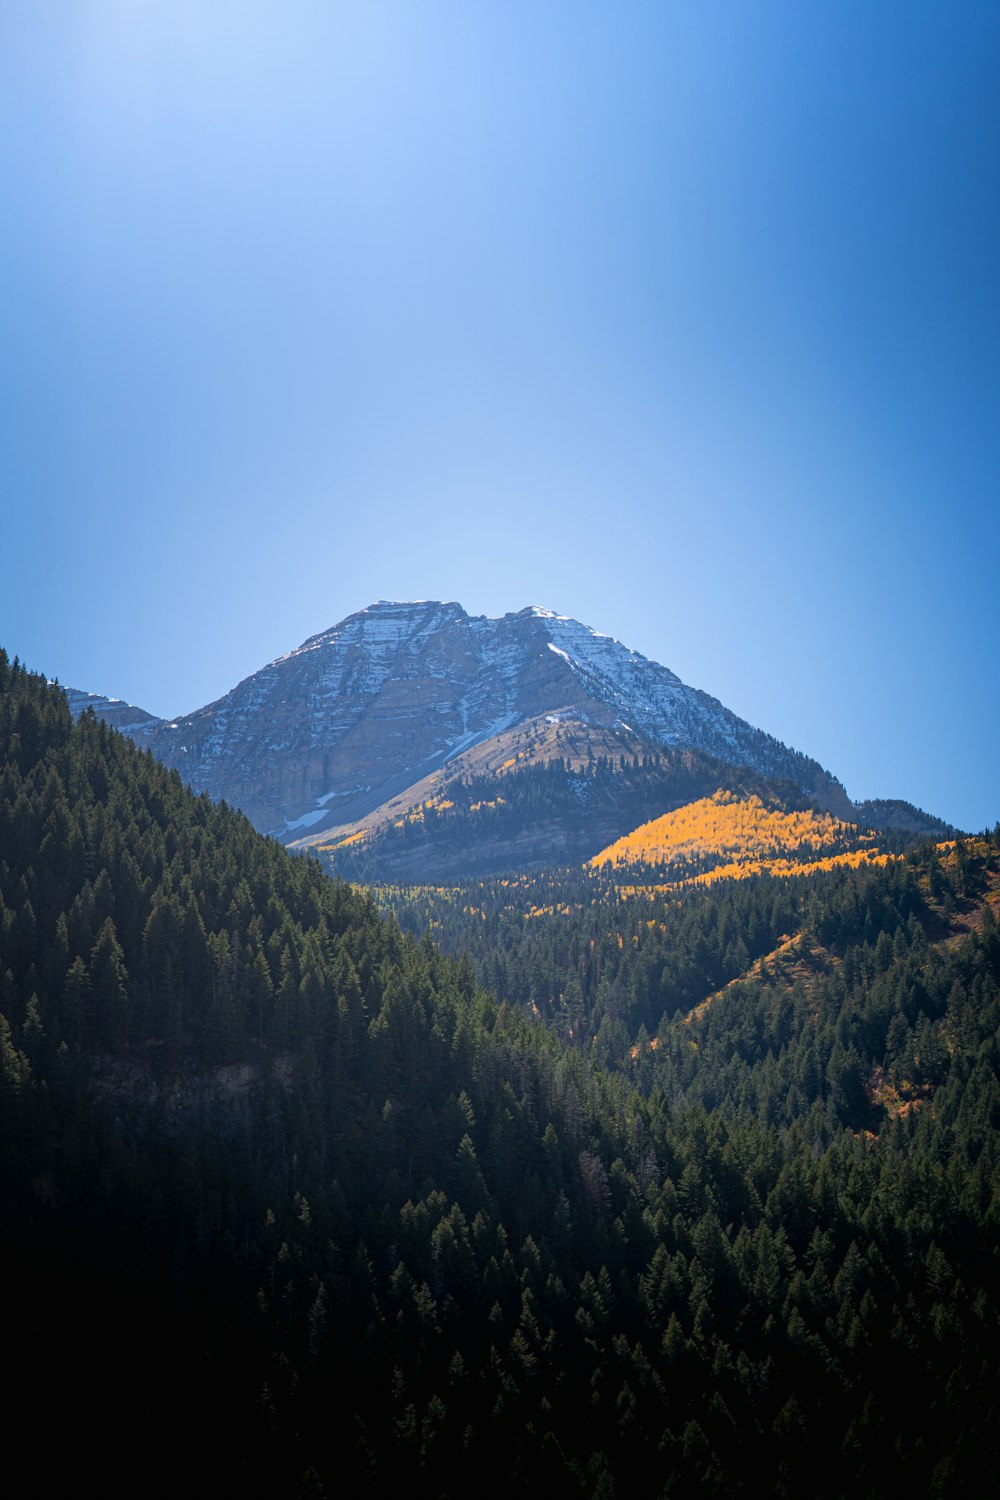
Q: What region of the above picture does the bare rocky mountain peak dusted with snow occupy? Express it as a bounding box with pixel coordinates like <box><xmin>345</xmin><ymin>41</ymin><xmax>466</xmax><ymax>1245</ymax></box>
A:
<box><xmin>70</xmin><ymin>602</ymin><xmax>852</xmax><ymax>843</ymax></box>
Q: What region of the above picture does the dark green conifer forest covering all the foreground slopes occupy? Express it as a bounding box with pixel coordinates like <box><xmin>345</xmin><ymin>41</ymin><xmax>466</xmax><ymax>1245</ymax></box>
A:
<box><xmin>0</xmin><ymin>656</ymin><xmax>1000</xmax><ymax>1497</ymax></box>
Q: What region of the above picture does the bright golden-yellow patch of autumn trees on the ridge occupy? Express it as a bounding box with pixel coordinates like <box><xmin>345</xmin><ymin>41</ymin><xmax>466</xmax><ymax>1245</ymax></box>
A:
<box><xmin>589</xmin><ymin>791</ymin><xmax>886</xmax><ymax>881</ymax></box>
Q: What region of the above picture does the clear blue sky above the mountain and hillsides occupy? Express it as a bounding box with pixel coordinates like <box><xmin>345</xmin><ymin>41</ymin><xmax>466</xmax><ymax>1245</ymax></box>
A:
<box><xmin>0</xmin><ymin>0</ymin><xmax>1000</xmax><ymax>828</ymax></box>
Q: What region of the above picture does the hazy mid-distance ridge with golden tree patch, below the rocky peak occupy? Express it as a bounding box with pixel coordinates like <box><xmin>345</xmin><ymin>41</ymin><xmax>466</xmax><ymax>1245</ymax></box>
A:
<box><xmin>314</xmin><ymin>750</ymin><xmax>955</xmax><ymax>885</ymax></box>
